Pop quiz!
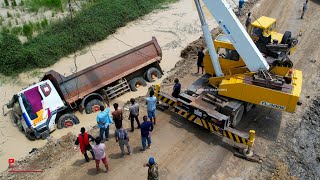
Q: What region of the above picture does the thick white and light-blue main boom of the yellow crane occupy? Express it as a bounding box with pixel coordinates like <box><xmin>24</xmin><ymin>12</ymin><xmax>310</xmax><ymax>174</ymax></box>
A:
<box><xmin>201</xmin><ymin>0</ymin><xmax>269</xmax><ymax>72</ymax></box>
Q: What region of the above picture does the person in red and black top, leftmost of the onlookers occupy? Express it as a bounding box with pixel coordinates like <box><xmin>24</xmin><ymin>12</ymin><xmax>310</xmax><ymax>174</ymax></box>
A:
<box><xmin>75</xmin><ymin>127</ymin><xmax>95</xmax><ymax>162</ymax></box>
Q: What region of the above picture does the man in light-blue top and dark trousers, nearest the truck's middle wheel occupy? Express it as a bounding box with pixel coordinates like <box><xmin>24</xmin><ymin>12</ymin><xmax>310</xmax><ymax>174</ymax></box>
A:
<box><xmin>96</xmin><ymin>106</ymin><xmax>113</xmax><ymax>141</ymax></box>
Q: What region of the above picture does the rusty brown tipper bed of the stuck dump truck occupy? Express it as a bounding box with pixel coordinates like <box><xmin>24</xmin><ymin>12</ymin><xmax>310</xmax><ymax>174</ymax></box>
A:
<box><xmin>42</xmin><ymin>37</ymin><xmax>162</xmax><ymax>104</ymax></box>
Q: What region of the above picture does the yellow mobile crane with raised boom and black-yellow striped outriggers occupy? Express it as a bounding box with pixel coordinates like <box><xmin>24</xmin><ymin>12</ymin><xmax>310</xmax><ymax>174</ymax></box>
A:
<box><xmin>156</xmin><ymin>0</ymin><xmax>302</xmax><ymax>158</ymax></box>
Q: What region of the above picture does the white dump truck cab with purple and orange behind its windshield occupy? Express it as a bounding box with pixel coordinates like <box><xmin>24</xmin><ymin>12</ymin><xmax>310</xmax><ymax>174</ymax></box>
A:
<box><xmin>13</xmin><ymin>80</ymin><xmax>66</xmax><ymax>138</ymax></box>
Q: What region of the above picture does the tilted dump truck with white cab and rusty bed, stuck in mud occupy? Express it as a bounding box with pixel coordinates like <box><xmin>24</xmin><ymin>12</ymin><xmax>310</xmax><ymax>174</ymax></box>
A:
<box><xmin>2</xmin><ymin>37</ymin><xmax>163</xmax><ymax>139</ymax></box>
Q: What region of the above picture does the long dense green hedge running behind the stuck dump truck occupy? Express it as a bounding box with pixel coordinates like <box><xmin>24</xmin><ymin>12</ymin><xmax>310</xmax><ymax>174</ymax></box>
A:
<box><xmin>0</xmin><ymin>0</ymin><xmax>178</xmax><ymax>74</ymax></box>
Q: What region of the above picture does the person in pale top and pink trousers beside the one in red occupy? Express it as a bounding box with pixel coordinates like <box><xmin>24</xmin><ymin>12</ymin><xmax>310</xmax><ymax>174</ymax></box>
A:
<box><xmin>92</xmin><ymin>137</ymin><xmax>109</xmax><ymax>173</ymax></box>
